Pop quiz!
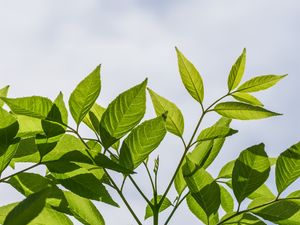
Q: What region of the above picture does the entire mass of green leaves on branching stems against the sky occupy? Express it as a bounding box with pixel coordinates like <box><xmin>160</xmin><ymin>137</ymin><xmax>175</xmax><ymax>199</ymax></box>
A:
<box><xmin>0</xmin><ymin>48</ymin><xmax>300</xmax><ymax>225</ymax></box>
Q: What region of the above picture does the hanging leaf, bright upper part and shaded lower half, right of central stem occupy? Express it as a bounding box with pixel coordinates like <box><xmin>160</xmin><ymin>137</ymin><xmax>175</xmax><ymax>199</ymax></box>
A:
<box><xmin>183</xmin><ymin>158</ymin><xmax>221</xmax><ymax>217</ymax></box>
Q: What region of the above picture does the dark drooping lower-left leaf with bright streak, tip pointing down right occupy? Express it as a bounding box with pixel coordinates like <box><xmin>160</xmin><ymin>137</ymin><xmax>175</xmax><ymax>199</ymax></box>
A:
<box><xmin>45</xmin><ymin>161</ymin><xmax>118</xmax><ymax>206</ymax></box>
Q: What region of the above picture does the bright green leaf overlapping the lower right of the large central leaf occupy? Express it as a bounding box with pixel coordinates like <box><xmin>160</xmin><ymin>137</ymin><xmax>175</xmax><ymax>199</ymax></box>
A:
<box><xmin>120</xmin><ymin>116</ymin><xmax>166</xmax><ymax>170</ymax></box>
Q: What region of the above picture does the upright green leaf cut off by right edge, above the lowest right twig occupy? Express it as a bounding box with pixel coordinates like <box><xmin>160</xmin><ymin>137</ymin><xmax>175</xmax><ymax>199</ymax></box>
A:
<box><xmin>275</xmin><ymin>142</ymin><xmax>300</xmax><ymax>193</ymax></box>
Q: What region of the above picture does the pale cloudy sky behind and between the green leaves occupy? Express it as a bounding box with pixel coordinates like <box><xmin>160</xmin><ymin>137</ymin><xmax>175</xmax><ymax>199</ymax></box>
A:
<box><xmin>0</xmin><ymin>0</ymin><xmax>300</xmax><ymax>225</ymax></box>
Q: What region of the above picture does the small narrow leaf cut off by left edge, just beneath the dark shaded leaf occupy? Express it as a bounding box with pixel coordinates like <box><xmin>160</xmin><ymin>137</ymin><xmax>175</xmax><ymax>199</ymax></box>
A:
<box><xmin>0</xmin><ymin>138</ymin><xmax>20</xmax><ymax>175</ymax></box>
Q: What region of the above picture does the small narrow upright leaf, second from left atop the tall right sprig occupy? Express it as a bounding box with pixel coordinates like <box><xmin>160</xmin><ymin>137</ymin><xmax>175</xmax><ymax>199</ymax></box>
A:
<box><xmin>227</xmin><ymin>48</ymin><xmax>246</xmax><ymax>92</ymax></box>
